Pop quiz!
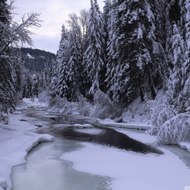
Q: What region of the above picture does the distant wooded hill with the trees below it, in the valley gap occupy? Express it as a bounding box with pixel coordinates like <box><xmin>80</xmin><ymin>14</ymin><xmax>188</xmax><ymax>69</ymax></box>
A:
<box><xmin>17</xmin><ymin>48</ymin><xmax>56</xmax><ymax>99</ymax></box>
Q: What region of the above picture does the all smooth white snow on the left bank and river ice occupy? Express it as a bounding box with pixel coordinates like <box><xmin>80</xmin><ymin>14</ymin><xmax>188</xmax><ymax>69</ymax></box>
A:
<box><xmin>0</xmin><ymin>100</ymin><xmax>190</xmax><ymax>190</ymax></box>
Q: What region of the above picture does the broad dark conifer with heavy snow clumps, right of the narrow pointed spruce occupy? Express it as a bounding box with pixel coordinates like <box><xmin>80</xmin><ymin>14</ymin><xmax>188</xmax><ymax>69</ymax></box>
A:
<box><xmin>107</xmin><ymin>0</ymin><xmax>161</xmax><ymax>103</ymax></box>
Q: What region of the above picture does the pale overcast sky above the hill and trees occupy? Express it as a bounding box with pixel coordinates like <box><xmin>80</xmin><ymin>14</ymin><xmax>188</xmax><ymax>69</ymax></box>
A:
<box><xmin>14</xmin><ymin>0</ymin><xmax>103</xmax><ymax>53</ymax></box>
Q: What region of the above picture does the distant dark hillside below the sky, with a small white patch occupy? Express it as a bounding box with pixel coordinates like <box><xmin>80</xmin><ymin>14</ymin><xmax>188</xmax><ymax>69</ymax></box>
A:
<box><xmin>20</xmin><ymin>48</ymin><xmax>55</xmax><ymax>73</ymax></box>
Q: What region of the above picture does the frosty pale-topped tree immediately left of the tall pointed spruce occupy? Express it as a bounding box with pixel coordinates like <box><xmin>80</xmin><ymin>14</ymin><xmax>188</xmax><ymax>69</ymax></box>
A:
<box><xmin>68</xmin><ymin>14</ymin><xmax>87</xmax><ymax>100</ymax></box>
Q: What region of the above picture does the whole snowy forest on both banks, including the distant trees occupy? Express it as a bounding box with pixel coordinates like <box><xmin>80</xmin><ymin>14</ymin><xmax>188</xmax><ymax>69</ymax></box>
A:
<box><xmin>0</xmin><ymin>0</ymin><xmax>190</xmax><ymax>143</ymax></box>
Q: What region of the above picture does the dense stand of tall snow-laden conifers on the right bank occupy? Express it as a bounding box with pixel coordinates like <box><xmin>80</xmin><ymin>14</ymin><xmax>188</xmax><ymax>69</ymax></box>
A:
<box><xmin>52</xmin><ymin>0</ymin><xmax>190</xmax><ymax>112</ymax></box>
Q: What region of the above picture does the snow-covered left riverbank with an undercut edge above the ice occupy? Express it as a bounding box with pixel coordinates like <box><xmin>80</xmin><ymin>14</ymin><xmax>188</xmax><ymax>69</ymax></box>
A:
<box><xmin>0</xmin><ymin>111</ymin><xmax>53</xmax><ymax>190</ymax></box>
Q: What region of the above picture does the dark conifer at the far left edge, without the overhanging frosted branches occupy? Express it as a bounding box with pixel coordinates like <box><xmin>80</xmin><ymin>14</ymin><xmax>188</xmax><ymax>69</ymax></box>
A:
<box><xmin>0</xmin><ymin>0</ymin><xmax>15</xmax><ymax>111</ymax></box>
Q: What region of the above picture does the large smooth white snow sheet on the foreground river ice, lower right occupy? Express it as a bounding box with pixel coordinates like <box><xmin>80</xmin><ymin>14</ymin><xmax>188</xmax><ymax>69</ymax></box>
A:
<box><xmin>61</xmin><ymin>140</ymin><xmax>190</xmax><ymax>190</ymax></box>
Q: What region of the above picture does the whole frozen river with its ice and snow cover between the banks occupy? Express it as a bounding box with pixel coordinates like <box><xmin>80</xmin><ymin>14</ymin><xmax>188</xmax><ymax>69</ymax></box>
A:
<box><xmin>11</xmin><ymin>110</ymin><xmax>190</xmax><ymax>190</ymax></box>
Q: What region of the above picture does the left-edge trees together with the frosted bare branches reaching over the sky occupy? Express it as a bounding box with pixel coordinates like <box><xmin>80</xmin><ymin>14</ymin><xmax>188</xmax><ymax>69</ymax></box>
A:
<box><xmin>0</xmin><ymin>0</ymin><xmax>40</xmax><ymax>111</ymax></box>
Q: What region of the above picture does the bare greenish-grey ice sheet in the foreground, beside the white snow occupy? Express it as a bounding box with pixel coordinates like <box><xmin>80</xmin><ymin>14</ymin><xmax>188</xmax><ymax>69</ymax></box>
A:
<box><xmin>12</xmin><ymin>138</ymin><xmax>109</xmax><ymax>190</ymax></box>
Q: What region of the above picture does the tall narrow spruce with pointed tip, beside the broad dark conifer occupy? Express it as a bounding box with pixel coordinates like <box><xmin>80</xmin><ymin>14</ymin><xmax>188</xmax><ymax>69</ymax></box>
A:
<box><xmin>84</xmin><ymin>0</ymin><xmax>105</xmax><ymax>95</ymax></box>
